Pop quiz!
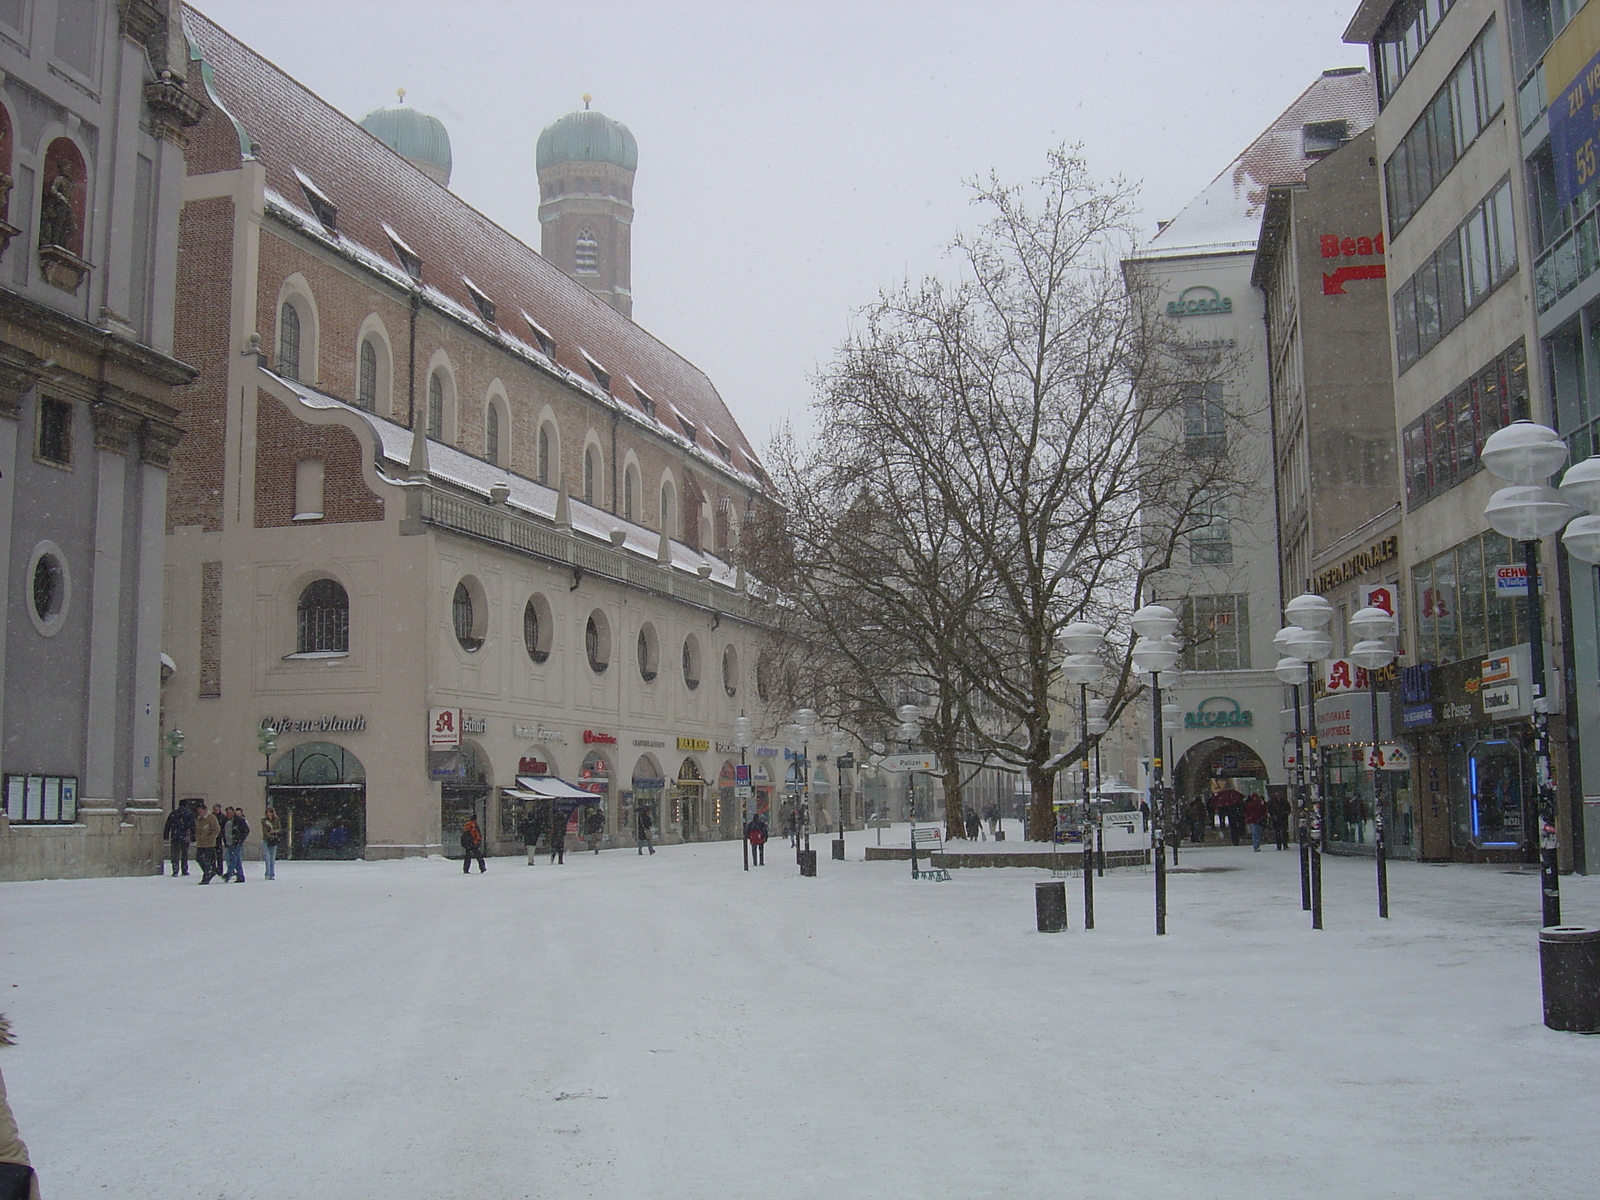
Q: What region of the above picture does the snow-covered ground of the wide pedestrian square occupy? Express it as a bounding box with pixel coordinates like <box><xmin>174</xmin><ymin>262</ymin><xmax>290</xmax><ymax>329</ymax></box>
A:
<box><xmin>0</xmin><ymin>830</ymin><xmax>1600</xmax><ymax>1200</ymax></box>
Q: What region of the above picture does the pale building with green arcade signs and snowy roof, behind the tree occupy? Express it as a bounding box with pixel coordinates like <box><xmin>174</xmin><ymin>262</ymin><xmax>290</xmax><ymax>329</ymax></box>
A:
<box><xmin>1128</xmin><ymin>67</ymin><xmax>1374</xmax><ymax>825</ymax></box>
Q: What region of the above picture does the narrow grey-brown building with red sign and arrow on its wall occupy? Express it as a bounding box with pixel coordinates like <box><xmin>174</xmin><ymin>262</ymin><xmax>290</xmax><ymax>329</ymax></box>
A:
<box><xmin>1253</xmin><ymin>130</ymin><xmax>1416</xmax><ymax>856</ymax></box>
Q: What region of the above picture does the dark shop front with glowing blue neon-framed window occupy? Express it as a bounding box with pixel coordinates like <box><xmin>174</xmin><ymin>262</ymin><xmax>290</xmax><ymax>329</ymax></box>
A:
<box><xmin>1400</xmin><ymin>643</ymin><xmax>1538</xmax><ymax>862</ymax></box>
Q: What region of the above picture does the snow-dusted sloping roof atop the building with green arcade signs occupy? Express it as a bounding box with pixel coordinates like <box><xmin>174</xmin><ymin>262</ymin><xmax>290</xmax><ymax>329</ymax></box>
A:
<box><xmin>1138</xmin><ymin>67</ymin><xmax>1378</xmax><ymax>259</ymax></box>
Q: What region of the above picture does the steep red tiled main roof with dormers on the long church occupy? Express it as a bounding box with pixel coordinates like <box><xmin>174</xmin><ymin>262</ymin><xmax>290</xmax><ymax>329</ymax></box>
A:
<box><xmin>184</xmin><ymin>6</ymin><xmax>760</xmax><ymax>477</ymax></box>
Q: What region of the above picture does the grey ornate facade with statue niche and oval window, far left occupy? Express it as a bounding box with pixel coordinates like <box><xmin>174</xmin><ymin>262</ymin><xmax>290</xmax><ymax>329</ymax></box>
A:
<box><xmin>0</xmin><ymin>0</ymin><xmax>200</xmax><ymax>878</ymax></box>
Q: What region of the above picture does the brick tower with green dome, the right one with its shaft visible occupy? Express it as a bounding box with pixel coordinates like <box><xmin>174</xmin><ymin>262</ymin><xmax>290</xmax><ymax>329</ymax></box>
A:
<box><xmin>536</xmin><ymin>96</ymin><xmax>638</xmax><ymax>318</ymax></box>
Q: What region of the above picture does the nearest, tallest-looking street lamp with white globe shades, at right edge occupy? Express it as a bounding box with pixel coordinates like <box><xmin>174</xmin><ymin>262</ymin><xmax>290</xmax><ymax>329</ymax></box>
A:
<box><xmin>1480</xmin><ymin>421</ymin><xmax>1600</xmax><ymax>925</ymax></box>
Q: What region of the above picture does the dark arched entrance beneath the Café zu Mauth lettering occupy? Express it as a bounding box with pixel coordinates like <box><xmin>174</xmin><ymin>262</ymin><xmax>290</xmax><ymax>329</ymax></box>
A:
<box><xmin>267</xmin><ymin>742</ymin><xmax>366</xmax><ymax>859</ymax></box>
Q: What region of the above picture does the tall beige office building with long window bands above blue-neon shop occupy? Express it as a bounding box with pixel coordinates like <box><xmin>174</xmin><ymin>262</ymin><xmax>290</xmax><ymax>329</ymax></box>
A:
<box><xmin>1346</xmin><ymin>0</ymin><xmax>1568</xmax><ymax>869</ymax></box>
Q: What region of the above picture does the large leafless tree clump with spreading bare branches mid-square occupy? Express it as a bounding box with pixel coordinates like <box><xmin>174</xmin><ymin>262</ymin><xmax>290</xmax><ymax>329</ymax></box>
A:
<box><xmin>757</xmin><ymin>149</ymin><xmax>1243</xmax><ymax>838</ymax></box>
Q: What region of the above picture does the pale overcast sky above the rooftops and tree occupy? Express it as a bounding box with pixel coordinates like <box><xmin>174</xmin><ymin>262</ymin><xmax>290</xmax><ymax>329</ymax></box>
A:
<box><xmin>187</xmin><ymin>0</ymin><xmax>1366</xmax><ymax>450</ymax></box>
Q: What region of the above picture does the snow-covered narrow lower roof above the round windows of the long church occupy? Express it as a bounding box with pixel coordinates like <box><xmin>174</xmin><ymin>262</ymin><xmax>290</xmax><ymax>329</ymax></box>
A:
<box><xmin>261</xmin><ymin>366</ymin><xmax>738</xmax><ymax>587</ymax></box>
